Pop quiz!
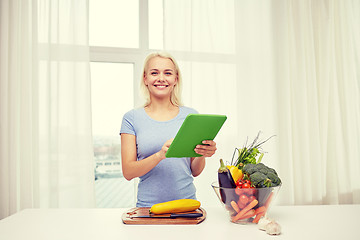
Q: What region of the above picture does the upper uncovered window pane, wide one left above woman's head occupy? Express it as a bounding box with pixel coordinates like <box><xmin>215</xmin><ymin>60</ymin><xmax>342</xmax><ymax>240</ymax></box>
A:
<box><xmin>89</xmin><ymin>0</ymin><xmax>139</xmax><ymax>48</ymax></box>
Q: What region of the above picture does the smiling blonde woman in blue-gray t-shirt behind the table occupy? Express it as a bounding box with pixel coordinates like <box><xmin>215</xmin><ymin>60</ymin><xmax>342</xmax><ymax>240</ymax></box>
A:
<box><xmin>120</xmin><ymin>53</ymin><xmax>216</xmax><ymax>207</ymax></box>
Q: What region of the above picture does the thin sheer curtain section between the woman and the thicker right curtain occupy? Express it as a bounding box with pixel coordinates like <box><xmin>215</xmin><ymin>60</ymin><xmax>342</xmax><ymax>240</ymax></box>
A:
<box><xmin>164</xmin><ymin>0</ymin><xmax>277</xmax><ymax>206</ymax></box>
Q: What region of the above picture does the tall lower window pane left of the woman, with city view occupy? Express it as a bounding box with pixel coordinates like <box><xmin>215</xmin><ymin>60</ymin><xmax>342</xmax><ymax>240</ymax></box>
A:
<box><xmin>90</xmin><ymin>62</ymin><xmax>135</xmax><ymax>208</ymax></box>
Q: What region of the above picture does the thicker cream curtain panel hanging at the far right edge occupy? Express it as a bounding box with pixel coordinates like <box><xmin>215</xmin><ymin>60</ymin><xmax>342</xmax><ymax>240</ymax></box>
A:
<box><xmin>273</xmin><ymin>0</ymin><xmax>360</xmax><ymax>204</ymax></box>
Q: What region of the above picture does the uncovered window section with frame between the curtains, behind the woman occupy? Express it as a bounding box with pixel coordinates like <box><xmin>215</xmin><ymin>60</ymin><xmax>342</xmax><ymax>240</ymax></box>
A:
<box><xmin>89</xmin><ymin>0</ymin><xmax>163</xmax><ymax>208</ymax></box>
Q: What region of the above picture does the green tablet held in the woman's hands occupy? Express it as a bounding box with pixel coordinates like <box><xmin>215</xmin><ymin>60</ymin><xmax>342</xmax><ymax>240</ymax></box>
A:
<box><xmin>165</xmin><ymin>114</ymin><xmax>227</xmax><ymax>158</ymax></box>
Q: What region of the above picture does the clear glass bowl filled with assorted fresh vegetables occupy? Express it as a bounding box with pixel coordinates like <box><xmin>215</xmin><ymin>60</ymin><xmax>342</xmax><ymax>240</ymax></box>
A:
<box><xmin>212</xmin><ymin>132</ymin><xmax>282</xmax><ymax>223</ymax></box>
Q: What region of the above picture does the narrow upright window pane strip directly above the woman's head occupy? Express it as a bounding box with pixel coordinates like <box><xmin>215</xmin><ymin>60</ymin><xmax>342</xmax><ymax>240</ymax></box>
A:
<box><xmin>149</xmin><ymin>0</ymin><xmax>164</xmax><ymax>49</ymax></box>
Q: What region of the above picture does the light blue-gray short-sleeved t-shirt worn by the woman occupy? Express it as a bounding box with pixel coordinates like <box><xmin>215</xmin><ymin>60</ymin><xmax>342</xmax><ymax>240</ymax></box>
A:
<box><xmin>120</xmin><ymin>106</ymin><xmax>197</xmax><ymax>207</ymax></box>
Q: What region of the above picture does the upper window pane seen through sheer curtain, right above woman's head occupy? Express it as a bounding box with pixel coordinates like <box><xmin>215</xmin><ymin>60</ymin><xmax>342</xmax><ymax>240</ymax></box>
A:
<box><xmin>164</xmin><ymin>0</ymin><xmax>236</xmax><ymax>54</ymax></box>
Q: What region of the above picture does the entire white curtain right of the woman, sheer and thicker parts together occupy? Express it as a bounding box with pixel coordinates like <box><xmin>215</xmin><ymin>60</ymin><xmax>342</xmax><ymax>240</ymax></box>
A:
<box><xmin>164</xmin><ymin>0</ymin><xmax>360</xmax><ymax>205</ymax></box>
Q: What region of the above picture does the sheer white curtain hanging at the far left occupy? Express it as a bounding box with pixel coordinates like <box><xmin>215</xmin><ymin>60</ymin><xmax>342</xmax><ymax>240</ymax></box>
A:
<box><xmin>0</xmin><ymin>0</ymin><xmax>95</xmax><ymax>218</ymax></box>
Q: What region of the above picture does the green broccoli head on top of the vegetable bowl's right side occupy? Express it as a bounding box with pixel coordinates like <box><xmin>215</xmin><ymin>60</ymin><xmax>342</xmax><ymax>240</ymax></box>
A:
<box><xmin>243</xmin><ymin>163</ymin><xmax>281</xmax><ymax>188</ymax></box>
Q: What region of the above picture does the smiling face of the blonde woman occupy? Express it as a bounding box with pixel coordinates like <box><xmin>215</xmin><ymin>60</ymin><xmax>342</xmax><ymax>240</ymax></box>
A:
<box><xmin>144</xmin><ymin>57</ymin><xmax>177</xmax><ymax>98</ymax></box>
